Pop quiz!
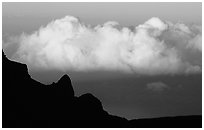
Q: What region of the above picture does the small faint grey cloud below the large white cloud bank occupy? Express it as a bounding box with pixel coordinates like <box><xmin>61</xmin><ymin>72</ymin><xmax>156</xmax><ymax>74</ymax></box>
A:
<box><xmin>147</xmin><ymin>82</ymin><xmax>169</xmax><ymax>92</ymax></box>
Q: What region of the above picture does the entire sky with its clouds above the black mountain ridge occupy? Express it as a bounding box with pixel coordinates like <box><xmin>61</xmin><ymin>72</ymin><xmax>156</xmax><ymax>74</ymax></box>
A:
<box><xmin>2</xmin><ymin>2</ymin><xmax>202</xmax><ymax>119</ymax></box>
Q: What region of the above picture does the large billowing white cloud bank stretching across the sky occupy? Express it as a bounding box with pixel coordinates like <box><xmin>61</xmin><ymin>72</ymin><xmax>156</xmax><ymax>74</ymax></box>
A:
<box><xmin>3</xmin><ymin>16</ymin><xmax>202</xmax><ymax>75</ymax></box>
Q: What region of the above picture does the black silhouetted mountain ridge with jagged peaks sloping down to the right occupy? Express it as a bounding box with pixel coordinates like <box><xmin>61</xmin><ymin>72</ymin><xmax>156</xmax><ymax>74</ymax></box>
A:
<box><xmin>2</xmin><ymin>50</ymin><xmax>202</xmax><ymax>128</ymax></box>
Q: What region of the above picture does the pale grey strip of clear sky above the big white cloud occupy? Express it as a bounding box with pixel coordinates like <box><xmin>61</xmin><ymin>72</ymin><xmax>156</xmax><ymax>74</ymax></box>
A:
<box><xmin>2</xmin><ymin>3</ymin><xmax>202</xmax><ymax>33</ymax></box>
